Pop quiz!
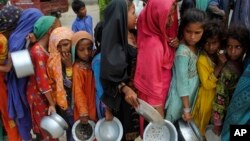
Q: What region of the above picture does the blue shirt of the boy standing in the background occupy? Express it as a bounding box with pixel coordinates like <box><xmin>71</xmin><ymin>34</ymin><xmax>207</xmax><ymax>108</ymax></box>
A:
<box><xmin>72</xmin><ymin>15</ymin><xmax>93</xmax><ymax>36</ymax></box>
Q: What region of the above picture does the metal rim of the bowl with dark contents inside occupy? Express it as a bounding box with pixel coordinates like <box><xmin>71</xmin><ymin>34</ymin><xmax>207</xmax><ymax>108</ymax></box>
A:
<box><xmin>72</xmin><ymin>120</ymin><xmax>96</xmax><ymax>141</ymax></box>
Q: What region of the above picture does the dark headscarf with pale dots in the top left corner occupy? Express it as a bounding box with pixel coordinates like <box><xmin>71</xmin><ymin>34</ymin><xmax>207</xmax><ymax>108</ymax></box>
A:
<box><xmin>0</xmin><ymin>6</ymin><xmax>22</xmax><ymax>32</ymax></box>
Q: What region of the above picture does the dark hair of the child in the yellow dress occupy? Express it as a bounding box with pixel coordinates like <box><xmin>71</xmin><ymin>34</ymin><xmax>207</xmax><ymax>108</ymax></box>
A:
<box><xmin>200</xmin><ymin>20</ymin><xmax>225</xmax><ymax>46</ymax></box>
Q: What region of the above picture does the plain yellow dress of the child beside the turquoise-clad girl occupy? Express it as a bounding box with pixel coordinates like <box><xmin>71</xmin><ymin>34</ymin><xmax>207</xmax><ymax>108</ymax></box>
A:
<box><xmin>192</xmin><ymin>53</ymin><xmax>217</xmax><ymax>136</ymax></box>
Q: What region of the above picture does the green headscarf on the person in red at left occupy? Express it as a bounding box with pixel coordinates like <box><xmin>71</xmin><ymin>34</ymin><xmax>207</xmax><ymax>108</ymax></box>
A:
<box><xmin>33</xmin><ymin>16</ymin><xmax>56</xmax><ymax>40</ymax></box>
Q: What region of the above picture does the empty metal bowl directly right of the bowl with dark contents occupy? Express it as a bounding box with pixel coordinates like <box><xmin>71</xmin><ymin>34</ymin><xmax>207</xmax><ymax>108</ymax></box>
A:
<box><xmin>95</xmin><ymin>117</ymin><xmax>123</xmax><ymax>141</ymax></box>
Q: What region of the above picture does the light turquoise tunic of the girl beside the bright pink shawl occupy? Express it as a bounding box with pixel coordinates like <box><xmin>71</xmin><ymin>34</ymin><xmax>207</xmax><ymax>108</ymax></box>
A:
<box><xmin>165</xmin><ymin>44</ymin><xmax>199</xmax><ymax>122</ymax></box>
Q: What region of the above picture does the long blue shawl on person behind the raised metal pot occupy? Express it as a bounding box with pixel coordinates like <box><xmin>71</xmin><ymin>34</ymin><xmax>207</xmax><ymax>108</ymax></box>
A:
<box><xmin>7</xmin><ymin>8</ymin><xmax>43</xmax><ymax>140</ymax></box>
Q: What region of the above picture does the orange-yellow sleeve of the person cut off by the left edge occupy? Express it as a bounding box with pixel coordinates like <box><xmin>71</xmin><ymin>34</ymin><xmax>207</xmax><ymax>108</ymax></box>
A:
<box><xmin>0</xmin><ymin>34</ymin><xmax>8</xmax><ymax>65</ymax></box>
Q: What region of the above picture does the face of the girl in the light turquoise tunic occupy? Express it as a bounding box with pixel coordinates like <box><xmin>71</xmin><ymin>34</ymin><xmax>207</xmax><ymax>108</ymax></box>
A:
<box><xmin>183</xmin><ymin>22</ymin><xmax>204</xmax><ymax>46</ymax></box>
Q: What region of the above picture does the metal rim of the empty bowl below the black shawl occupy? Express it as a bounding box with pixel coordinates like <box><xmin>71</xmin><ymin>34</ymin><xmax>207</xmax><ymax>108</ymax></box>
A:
<box><xmin>95</xmin><ymin>117</ymin><xmax>123</xmax><ymax>141</ymax></box>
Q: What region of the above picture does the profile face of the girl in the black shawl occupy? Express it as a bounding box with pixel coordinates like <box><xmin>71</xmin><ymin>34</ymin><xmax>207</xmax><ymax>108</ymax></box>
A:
<box><xmin>128</xmin><ymin>4</ymin><xmax>137</xmax><ymax>30</ymax></box>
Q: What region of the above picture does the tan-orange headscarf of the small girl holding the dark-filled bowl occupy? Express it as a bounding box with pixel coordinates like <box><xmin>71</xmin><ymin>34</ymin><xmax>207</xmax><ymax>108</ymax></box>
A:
<box><xmin>72</xmin><ymin>31</ymin><xmax>93</xmax><ymax>62</ymax></box>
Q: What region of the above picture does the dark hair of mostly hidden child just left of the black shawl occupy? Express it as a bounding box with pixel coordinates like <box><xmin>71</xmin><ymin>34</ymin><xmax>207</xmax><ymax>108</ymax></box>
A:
<box><xmin>94</xmin><ymin>21</ymin><xmax>104</xmax><ymax>55</ymax></box>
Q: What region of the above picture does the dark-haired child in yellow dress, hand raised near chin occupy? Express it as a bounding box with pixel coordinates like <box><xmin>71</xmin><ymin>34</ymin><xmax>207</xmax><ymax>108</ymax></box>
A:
<box><xmin>192</xmin><ymin>22</ymin><xmax>226</xmax><ymax>137</ymax></box>
